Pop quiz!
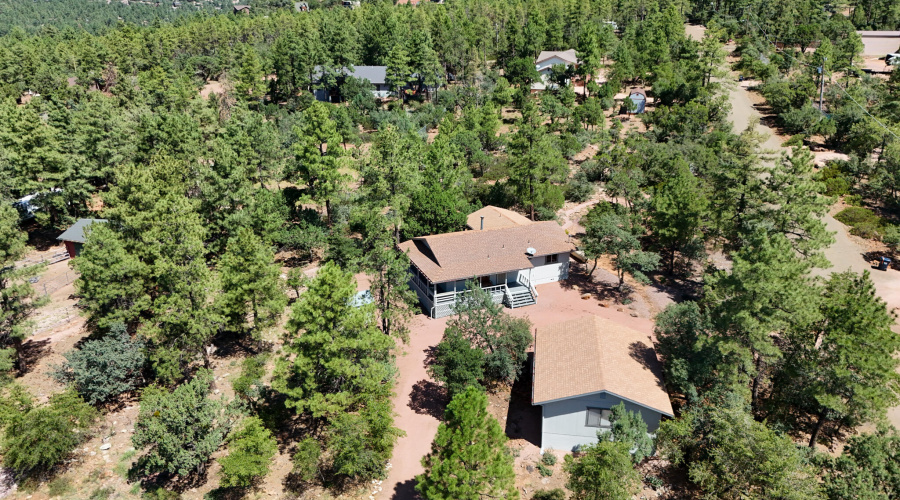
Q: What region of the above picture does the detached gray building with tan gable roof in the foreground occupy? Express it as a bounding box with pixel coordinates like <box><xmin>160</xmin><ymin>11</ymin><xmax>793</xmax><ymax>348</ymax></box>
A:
<box><xmin>531</xmin><ymin>316</ymin><xmax>673</xmax><ymax>452</ymax></box>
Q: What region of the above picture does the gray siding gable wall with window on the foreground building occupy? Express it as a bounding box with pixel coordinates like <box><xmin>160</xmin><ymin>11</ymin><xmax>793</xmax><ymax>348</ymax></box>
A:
<box><xmin>541</xmin><ymin>393</ymin><xmax>661</xmax><ymax>452</ymax></box>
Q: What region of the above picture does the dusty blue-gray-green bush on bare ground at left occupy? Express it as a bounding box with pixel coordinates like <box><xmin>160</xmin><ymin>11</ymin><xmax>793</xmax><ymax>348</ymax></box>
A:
<box><xmin>53</xmin><ymin>323</ymin><xmax>145</xmax><ymax>405</ymax></box>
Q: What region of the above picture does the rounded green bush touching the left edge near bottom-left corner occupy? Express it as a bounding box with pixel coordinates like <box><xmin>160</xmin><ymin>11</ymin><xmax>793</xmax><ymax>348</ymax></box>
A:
<box><xmin>3</xmin><ymin>390</ymin><xmax>98</xmax><ymax>473</ymax></box>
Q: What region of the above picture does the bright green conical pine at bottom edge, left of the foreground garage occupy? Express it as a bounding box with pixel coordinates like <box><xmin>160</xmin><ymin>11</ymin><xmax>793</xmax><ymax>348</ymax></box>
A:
<box><xmin>416</xmin><ymin>387</ymin><xmax>519</xmax><ymax>500</ymax></box>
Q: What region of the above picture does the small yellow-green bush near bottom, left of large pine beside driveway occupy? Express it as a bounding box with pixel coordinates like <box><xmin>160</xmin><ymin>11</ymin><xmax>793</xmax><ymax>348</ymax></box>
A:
<box><xmin>219</xmin><ymin>417</ymin><xmax>278</xmax><ymax>488</ymax></box>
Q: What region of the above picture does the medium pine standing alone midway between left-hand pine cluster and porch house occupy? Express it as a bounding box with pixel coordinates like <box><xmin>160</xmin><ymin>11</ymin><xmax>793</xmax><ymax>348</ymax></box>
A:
<box><xmin>219</xmin><ymin>228</ymin><xmax>287</xmax><ymax>336</ymax></box>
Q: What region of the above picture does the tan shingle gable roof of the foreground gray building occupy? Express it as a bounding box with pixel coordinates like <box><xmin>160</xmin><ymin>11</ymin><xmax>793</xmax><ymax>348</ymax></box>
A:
<box><xmin>532</xmin><ymin>316</ymin><xmax>672</xmax><ymax>416</ymax></box>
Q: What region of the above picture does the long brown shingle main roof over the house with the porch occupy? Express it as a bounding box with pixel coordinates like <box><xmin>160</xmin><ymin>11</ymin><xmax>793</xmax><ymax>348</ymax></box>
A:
<box><xmin>400</xmin><ymin>221</ymin><xmax>573</xmax><ymax>283</ymax></box>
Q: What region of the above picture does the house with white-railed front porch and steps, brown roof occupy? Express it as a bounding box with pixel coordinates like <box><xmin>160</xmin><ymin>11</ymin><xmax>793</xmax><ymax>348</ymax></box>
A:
<box><xmin>399</xmin><ymin>209</ymin><xmax>573</xmax><ymax>318</ymax></box>
